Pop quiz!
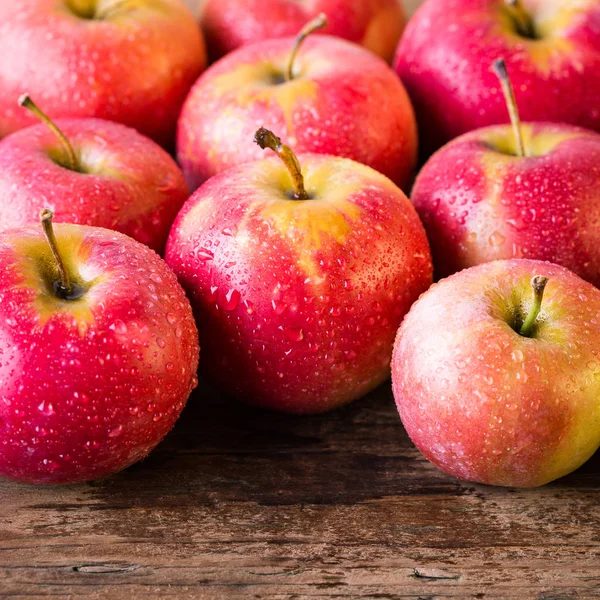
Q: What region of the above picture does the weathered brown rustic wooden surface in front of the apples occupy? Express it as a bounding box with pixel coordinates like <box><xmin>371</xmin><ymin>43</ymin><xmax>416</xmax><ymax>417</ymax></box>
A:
<box><xmin>0</xmin><ymin>386</ymin><xmax>600</xmax><ymax>600</ymax></box>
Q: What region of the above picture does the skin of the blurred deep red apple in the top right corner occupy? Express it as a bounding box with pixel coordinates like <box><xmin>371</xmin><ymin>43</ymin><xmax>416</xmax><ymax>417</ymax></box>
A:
<box><xmin>394</xmin><ymin>0</ymin><xmax>600</xmax><ymax>156</ymax></box>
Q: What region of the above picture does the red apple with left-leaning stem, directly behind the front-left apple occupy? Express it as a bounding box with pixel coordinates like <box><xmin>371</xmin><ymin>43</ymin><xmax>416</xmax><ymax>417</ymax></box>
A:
<box><xmin>0</xmin><ymin>96</ymin><xmax>189</xmax><ymax>252</ymax></box>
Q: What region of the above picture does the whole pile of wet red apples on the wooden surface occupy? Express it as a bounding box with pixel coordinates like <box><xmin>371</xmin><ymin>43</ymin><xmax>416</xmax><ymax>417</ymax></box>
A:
<box><xmin>0</xmin><ymin>0</ymin><xmax>600</xmax><ymax>487</ymax></box>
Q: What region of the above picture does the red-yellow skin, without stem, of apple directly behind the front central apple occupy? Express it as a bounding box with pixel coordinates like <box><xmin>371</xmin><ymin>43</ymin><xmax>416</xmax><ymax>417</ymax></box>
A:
<box><xmin>177</xmin><ymin>35</ymin><xmax>417</xmax><ymax>190</ymax></box>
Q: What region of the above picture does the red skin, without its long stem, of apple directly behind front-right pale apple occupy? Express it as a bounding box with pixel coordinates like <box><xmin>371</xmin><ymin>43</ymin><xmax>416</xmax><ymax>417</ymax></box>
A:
<box><xmin>411</xmin><ymin>123</ymin><xmax>600</xmax><ymax>287</ymax></box>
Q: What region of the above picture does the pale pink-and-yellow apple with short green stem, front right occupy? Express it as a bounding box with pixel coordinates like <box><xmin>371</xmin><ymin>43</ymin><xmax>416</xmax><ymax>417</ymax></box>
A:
<box><xmin>392</xmin><ymin>259</ymin><xmax>600</xmax><ymax>487</ymax></box>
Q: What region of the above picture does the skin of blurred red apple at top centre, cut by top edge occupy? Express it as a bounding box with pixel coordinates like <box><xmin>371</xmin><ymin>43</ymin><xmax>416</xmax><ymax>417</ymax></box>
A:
<box><xmin>201</xmin><ymin>0</ymin><xmax>406</xmax><ymax>62</ymax></box>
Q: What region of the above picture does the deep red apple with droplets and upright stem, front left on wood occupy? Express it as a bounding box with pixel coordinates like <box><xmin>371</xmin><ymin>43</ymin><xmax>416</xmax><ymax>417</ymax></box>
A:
<box><xmin>0</xmin><ymin>211</ymin><xmax>198</xmax><ymax>484</ymax></box>
